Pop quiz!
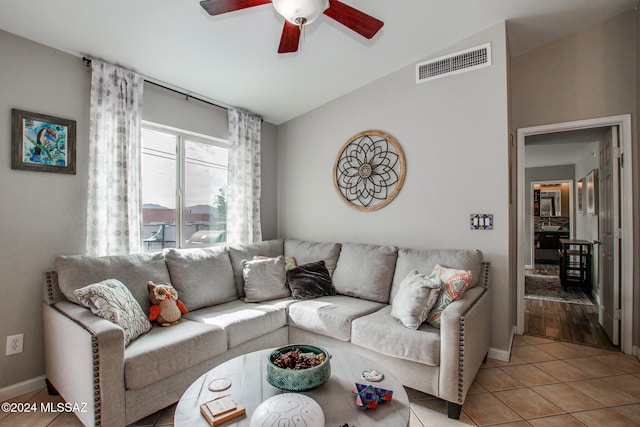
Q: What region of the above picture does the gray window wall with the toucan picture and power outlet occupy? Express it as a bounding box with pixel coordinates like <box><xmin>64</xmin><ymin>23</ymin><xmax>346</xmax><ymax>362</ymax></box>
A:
<box><xmin>0</xmin><ymin>31</ymin><xmax>277</xmax><ymax>392</ymax></box>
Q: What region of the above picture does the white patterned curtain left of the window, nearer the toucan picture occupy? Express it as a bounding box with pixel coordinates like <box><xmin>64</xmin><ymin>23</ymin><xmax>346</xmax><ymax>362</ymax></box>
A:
<box><xmin>86</xmin><ymin>60</ymin><xmax>144</xmax><ymax>256</ymax></box>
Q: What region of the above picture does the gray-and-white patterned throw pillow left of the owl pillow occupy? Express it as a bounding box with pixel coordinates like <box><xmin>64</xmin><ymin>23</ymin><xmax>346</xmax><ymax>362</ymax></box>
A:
<box><xmin>73</xmin><ymin>279</ymin><xmax>151</xmax><ymax>346</ymax></box>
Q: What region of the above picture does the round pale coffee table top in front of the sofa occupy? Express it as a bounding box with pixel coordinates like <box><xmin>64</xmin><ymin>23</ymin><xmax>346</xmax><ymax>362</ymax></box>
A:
<box><xmin>174</xmin><ymin>348</ymin><xmax>410</xmax><ymax>427</ymax></box>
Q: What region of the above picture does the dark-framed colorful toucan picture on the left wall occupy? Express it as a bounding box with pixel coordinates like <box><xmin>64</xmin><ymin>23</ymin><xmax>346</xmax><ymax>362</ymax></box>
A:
<box><xmin>11</xmin><ymin>108</ymin><xmax>76</xmax><ymax>174</ymax></box>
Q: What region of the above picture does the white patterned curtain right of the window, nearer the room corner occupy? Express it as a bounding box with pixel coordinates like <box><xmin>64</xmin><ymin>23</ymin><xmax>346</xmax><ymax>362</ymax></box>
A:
<box><xmin>227</xmin><ymin>109</ymin><xmax>262</xmax><ymax>244</ymax></box>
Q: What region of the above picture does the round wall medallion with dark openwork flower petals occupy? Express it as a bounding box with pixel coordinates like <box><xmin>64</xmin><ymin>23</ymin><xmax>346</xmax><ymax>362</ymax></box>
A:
<box><xmin>333</xmin><ymin>130</ymin><xmax>406</xmax><ymax>211</ymax></box>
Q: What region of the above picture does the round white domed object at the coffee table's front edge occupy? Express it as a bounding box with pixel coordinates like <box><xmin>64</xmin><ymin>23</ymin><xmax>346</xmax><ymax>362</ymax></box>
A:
<box><xmin>249</xmin><ymin>393</ymin><xmax>324</xmax><ymax>427</ymax></box>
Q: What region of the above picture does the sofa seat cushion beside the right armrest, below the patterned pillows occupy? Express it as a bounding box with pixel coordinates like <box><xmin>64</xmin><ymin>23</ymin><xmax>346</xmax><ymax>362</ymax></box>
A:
<box><xmin>351</xmin><ymin>306</ymin><xmax>440</xmax><ymax>366</ymax></box>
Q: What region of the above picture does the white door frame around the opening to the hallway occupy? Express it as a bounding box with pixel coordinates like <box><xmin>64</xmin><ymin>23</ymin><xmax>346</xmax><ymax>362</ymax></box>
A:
<box><xmin>516</xmin><ymin>114</ymin><xmax>634</xmax><ymax>354</ymax></box>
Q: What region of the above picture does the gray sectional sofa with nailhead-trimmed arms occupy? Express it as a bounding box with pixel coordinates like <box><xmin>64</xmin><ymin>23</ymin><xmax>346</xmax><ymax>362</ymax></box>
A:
<box><xmin>43</xmin><ymin>240</ymin><xmax>491</xmax><ymax>427</ymax></box>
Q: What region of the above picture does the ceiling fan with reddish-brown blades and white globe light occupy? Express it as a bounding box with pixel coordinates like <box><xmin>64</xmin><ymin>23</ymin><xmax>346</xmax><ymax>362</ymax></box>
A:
<box><xmin>200</xmin><ymin>0</ymin><xmax>384</xmax><ymax>53</ymax></box>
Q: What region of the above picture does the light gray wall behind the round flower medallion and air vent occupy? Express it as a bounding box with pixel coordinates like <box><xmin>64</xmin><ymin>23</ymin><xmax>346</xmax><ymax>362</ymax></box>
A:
<box><xmin>278</xmin><ymin>24</ymin><xmax>514</xmax><ymax>351</ymax></box>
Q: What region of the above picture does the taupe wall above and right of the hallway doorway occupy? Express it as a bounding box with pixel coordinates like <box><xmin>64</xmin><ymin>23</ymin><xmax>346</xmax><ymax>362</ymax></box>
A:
<box><xmin>511</xmin><ymin>10</ymin><xmax>640</xmax><ymax>346</ymax></box>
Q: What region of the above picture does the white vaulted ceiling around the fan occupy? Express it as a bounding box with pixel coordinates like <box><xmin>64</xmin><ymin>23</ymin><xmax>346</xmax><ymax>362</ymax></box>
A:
<box><xmin>0</xmin><ymin>0</ymin><xmax>638</xmax><ymax>124</ymax></box>
